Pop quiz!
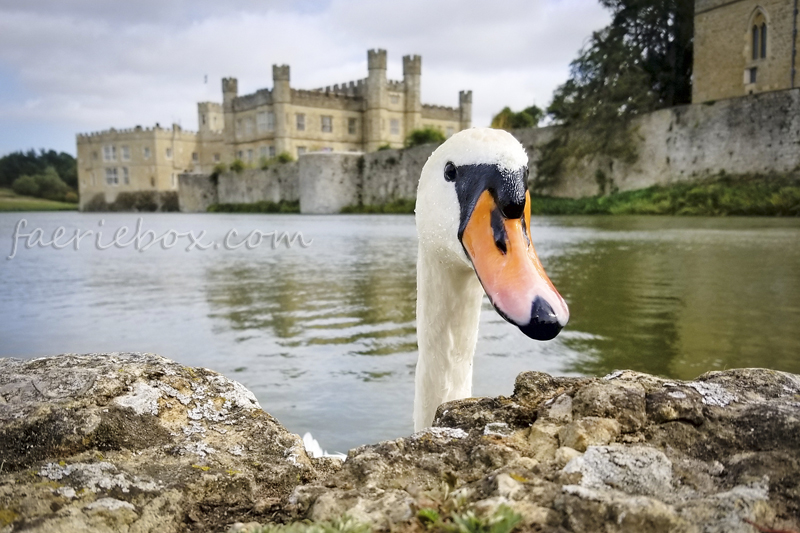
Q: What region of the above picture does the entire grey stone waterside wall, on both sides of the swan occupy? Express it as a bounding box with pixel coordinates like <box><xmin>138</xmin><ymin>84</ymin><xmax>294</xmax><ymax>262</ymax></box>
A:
<box><xmin>180</xmin><ymin>89</ymin><xmax>800</xmax><ymax>210</ymax></box>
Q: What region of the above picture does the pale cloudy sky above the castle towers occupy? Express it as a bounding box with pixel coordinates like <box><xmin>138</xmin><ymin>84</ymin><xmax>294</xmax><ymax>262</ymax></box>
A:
<box><xmin>0</xmin><ymin>0</ymin><xmax>609</xmax><ymax>156</ymax></box>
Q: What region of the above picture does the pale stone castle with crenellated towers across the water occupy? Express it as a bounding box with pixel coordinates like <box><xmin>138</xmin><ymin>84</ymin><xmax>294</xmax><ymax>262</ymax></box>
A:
<box><xmin>77</xmin><ymin>50</ymin><xmax>472</xmax><ymax>208</ymax></box>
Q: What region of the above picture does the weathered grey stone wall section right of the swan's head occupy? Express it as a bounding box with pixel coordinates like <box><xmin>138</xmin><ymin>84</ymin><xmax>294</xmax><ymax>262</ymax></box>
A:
<box><xmin>514</xmin><ymin>89</ymin><xmax>800</xmax><ymax>198</ymax></box>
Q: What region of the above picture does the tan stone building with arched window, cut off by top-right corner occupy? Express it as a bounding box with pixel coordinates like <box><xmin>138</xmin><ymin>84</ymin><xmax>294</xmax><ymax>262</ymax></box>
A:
<box><xmin>692</xmin><ymin>0</ymin><xmax>800</xmax><ymax>104</ymax></box>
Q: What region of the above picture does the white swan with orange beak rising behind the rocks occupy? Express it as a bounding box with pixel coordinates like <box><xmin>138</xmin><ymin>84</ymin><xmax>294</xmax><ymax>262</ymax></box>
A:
<box><xmin>414</xmin><ymin>128</ymin><xmax>569</xmax><ymax>431</ymax></box>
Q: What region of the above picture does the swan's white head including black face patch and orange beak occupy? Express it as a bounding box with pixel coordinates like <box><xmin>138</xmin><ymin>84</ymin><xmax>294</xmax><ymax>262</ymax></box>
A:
<box><xmin>415</xmin><ymin>128</ymin><xmax>569</xmax><ymax>340</ymax></box>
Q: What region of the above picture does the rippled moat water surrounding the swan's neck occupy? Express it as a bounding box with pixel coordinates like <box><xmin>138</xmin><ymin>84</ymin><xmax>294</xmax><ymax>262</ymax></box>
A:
<box><xmin>0</xmin><ymin>213</ymin><xmax>800</xmax><ymax>451</ymax></box>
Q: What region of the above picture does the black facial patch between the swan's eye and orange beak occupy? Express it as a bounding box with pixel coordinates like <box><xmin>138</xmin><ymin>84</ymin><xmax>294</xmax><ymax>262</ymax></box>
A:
<box><xmin>455</xmin><ymin>163</ymin><xmax>528</xmax><ymax>240</ymax></box>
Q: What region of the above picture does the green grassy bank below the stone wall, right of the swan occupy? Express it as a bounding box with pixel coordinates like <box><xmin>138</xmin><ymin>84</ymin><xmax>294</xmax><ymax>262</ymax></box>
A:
<box><xmin>531</xmin><ymin>174</ymin><xmax>800</xmax><ymax>216</ymax></box>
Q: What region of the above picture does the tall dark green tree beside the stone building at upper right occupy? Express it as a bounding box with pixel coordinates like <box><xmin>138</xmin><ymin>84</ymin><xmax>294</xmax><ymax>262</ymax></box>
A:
<box><xmin>532</xmin><ymin>0</ymin><xmax>694</xmax><ymax>190</ymax></box>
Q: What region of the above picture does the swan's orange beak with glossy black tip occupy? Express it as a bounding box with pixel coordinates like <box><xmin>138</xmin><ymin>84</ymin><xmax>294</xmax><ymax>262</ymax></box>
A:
<box><xmin>461</xmin><ymin>191</ymin><xmax>569</xmax><ymax>340</ymax></box>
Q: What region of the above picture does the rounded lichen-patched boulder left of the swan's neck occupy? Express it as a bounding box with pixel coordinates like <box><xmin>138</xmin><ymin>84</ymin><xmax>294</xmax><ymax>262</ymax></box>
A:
<box><xmin>0</xmin><ymin>354</ymin><xmax>317</xmax><ymax>532</ymax></box>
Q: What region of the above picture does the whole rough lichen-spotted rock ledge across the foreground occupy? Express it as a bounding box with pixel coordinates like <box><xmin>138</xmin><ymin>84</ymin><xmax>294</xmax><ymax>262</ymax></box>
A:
<box><xmin>0</xmin><ymin>354</ymin><xmax>800</xmax><ymax>533</ymax></box>
